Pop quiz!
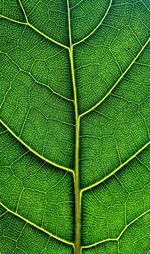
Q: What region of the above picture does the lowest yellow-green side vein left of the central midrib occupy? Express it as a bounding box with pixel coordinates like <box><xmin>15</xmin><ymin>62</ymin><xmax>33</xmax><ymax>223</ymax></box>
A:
<box><xmin>0</xmin><ymin>202</ymin><xmax>74</xmax><ymax>246</ymax></box>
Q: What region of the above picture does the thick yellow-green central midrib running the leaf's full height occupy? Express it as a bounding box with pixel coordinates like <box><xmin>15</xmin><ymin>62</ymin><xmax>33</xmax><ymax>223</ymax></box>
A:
<box><xmin>67</xmin><ymin>0</ymin><xmax>81</xmax><ymax>254</ymax></box>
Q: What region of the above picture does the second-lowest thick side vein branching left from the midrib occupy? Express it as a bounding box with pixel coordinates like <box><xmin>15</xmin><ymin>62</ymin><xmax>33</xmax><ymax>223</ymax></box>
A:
<box><xmin>0</xmin><ymin>119</ymin><xmax>74</xmax><ymax>174</ymax></box>
